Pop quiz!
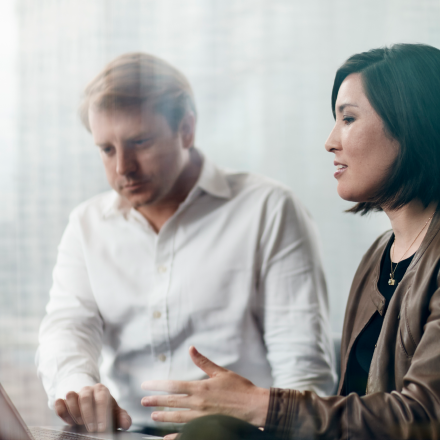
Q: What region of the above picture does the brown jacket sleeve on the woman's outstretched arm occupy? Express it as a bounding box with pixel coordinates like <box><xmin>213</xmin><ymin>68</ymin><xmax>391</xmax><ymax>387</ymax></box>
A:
<box><xmin>266</xmin><ymin>289</ymin><xmax>440</xmax><ymax>440</ymax></box>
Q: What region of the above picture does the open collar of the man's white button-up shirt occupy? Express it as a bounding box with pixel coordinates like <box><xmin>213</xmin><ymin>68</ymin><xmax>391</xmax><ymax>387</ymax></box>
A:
<box><xmin>103</xmin><ymin>151</ymin><xmax>232</xmax><ymax>219</ymax></box>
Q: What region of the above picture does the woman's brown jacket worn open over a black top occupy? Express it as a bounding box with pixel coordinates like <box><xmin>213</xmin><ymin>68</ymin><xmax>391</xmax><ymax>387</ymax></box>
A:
<box><xmin>266</xmin><ymin>212</ymin><xmax>440</xmax><ymax>440</ymax></box>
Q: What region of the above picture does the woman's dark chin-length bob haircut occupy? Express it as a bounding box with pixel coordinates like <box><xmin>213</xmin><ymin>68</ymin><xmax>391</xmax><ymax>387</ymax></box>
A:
<box><xmin>332</xmin><ymin>44</ymin><xmax>440</xmax><ymax>215</ymax></box>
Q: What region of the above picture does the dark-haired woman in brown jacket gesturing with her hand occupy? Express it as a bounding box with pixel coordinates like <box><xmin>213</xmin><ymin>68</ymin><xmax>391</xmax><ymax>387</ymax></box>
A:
<box><xmin>142</xmin><ymin>44</ymin><xmax>440</xmax><ymax>440</ymax></box>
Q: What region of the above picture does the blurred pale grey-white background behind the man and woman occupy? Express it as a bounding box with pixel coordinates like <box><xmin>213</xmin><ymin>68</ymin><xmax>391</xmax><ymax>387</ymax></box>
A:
<box><xmin>0</xmin><ymin>0</ymin><xmax>440</xmax><ymax>425</ymax></box>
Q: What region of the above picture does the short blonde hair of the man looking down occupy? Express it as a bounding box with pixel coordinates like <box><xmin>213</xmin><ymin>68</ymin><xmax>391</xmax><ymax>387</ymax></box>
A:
<box><xmin>79</xmin><ymin>52</ymin><xmax>196</xmax><ymax>131</ymax></box>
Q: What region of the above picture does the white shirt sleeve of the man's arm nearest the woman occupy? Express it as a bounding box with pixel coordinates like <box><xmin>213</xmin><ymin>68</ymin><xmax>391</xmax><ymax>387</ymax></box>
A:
<box><xmin>257</xmin><ymin>191</ymin><xmax>336</xmax><ymax>396</ymax></box>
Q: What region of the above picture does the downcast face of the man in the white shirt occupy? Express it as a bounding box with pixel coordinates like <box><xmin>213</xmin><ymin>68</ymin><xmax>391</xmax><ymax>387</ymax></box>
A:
<box><xmin>89</xmin><ymin>109</ymin><xmax>193</xmax><ymax>208</ymax></box>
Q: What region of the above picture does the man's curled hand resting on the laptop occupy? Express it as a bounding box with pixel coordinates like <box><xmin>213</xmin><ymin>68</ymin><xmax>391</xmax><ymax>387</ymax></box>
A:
<box><xmin>55</xmin><ymin>383</ymin><xmax>131</xmax><ymax>432</ymax></box>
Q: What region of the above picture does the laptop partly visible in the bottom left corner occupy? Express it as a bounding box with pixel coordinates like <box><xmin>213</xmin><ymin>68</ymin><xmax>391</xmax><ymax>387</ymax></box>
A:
<box><xmin>0</xmin><ymin>384</ymin><xmax>162</xmax><ymax>440</ymax></box>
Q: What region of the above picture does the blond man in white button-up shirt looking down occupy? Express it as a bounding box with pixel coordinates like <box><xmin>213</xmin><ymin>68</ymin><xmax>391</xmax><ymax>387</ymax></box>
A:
<box><xmin>37</xmin><ymin>53</ymin><xmax>335</xmax><ymax>432</ymax></box>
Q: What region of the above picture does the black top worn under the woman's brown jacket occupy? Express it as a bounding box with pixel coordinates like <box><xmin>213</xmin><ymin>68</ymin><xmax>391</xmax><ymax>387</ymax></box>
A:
<box><xmin>344</xmin><ymin>236</ymin><xmax>414</xmax><ymax>396</ymax></box>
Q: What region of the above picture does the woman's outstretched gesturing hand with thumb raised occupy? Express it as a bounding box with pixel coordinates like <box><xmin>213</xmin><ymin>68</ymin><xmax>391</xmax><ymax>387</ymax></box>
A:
<box><xmin>141</xmin><ymin>347</ymin><xmax>269</xmax><ymax>426</ymax></box>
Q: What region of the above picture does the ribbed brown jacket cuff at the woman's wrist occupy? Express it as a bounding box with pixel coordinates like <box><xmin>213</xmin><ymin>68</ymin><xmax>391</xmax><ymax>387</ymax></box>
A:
<box><xmin>264</xmin><ymin>388</ymin><xmax>298</xmax><ymax>439</ymax></box>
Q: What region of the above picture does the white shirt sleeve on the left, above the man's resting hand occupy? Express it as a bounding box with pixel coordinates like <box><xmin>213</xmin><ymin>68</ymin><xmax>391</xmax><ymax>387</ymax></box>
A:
<box><xmin>36</xmin><ymin>211</ymin><xmax>103</xmax><ymax>408</ymax></box>
